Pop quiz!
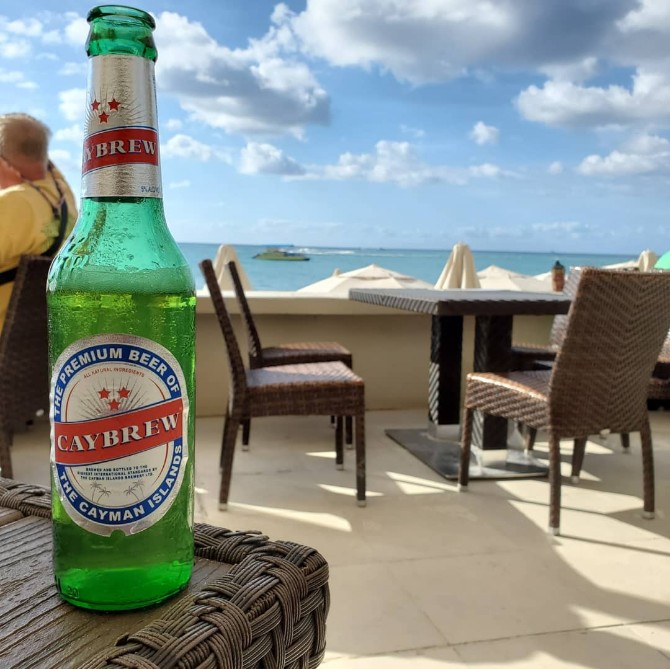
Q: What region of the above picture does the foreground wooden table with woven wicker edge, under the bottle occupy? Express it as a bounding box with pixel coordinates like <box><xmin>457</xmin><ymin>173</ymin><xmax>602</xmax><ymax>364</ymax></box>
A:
<box><xmin>0</xmin><ymin>478</ymin><xmax>329</xmax><ymax>669</ymax></box>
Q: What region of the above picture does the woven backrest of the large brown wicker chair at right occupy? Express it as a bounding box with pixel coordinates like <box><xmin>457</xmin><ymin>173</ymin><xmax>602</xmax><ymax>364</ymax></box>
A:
<box><xmin>550</xmin><ymin>267</ymin><xmax>670</xmax><ymax>436</ymax></box>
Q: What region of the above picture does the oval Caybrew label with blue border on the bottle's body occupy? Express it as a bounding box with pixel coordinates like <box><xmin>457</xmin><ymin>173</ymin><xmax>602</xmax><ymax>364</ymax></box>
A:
<box><xmin>51</xmin><ymin>335</ymin><xmax>189</xmax><ymax>535</ymax></box>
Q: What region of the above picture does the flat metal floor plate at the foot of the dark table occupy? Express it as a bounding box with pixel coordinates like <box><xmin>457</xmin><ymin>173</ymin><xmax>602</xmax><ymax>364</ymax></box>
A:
<box><xmin>386</xmin><ymin>428</ymin><xmax>548</xmax><ymax>480</ymax></box>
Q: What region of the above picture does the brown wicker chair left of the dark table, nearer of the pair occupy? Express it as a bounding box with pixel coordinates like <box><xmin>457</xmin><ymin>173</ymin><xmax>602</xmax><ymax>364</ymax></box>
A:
<box><xmin>200</xmin><ymin>260</ymin><xmax>365</xmax><ymax>509</ymax></box>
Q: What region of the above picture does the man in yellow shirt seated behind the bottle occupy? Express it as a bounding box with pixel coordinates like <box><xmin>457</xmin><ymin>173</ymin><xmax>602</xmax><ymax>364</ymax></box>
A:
<box><xmin>0</xmin><ymin>114</ymin><xmax>77</xmax><ymax>330</ymax></box>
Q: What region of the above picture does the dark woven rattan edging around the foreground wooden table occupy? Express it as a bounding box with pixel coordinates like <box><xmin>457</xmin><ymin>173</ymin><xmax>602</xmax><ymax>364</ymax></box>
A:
<box><xmin>0</xmin><ymin>479</ymin><xmax>330</xmax><ymax>669</ymax></box>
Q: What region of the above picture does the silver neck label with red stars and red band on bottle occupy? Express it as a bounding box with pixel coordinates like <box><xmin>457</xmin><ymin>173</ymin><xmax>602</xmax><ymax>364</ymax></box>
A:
<box><xmin>81</xmin><ymin>55</ymin><xmax>162</xmax><ymax>197</ymax></box>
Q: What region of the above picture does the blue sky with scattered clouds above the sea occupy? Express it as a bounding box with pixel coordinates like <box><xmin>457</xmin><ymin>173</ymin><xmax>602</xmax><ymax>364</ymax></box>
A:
<box><xmin>0</xmin><ymin>0</ymin><xmax>670</xmax><ymax>256</ymax></box>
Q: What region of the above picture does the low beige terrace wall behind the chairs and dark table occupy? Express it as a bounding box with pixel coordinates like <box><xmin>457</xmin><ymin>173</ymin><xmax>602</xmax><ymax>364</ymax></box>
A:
<box><xmin>196</xmin><ymin>291</ymin><xmax>552</xmax><ymax>416</ymax></box>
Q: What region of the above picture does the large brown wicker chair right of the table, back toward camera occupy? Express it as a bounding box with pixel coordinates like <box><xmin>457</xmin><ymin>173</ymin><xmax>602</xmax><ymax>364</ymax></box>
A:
<box><xmin>459</xmin><ymin>268</ymin><xmax>670</xmax><ymax>534</ymax></box>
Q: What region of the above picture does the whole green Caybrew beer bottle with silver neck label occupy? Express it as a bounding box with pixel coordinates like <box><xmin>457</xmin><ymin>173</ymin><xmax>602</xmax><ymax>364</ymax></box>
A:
<box><xmin>47</xmin><ymin>6</ymin><xmax>195</xmax><ymax>611</ymax></box>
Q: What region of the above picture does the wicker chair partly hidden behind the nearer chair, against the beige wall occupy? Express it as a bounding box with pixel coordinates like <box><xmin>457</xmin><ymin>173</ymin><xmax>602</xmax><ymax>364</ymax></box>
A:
<box><xmin>226</xmin><ymin>260</ymin><xmax>353</xmax><ymax>446</ymax></box>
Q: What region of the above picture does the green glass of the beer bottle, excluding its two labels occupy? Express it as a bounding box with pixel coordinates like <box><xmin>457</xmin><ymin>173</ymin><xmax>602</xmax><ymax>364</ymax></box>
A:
<box><xmin>47</xmin><ymin>6</ymin><xmax>195</xmax><ymax>610</ymax></box>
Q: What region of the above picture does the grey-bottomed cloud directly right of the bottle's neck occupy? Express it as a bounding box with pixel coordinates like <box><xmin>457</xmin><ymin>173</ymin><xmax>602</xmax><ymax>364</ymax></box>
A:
<box><xmin>155</xmin><ymin>12</ymin><xmax>329</xmax><ymax>136</ymax></box>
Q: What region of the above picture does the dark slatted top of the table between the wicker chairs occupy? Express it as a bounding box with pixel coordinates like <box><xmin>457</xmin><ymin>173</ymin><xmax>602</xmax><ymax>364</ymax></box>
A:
<box><xmin>349</xmin><ymin>288</ymin><xmax>570</xmax><ymax>316</ymax></box>
